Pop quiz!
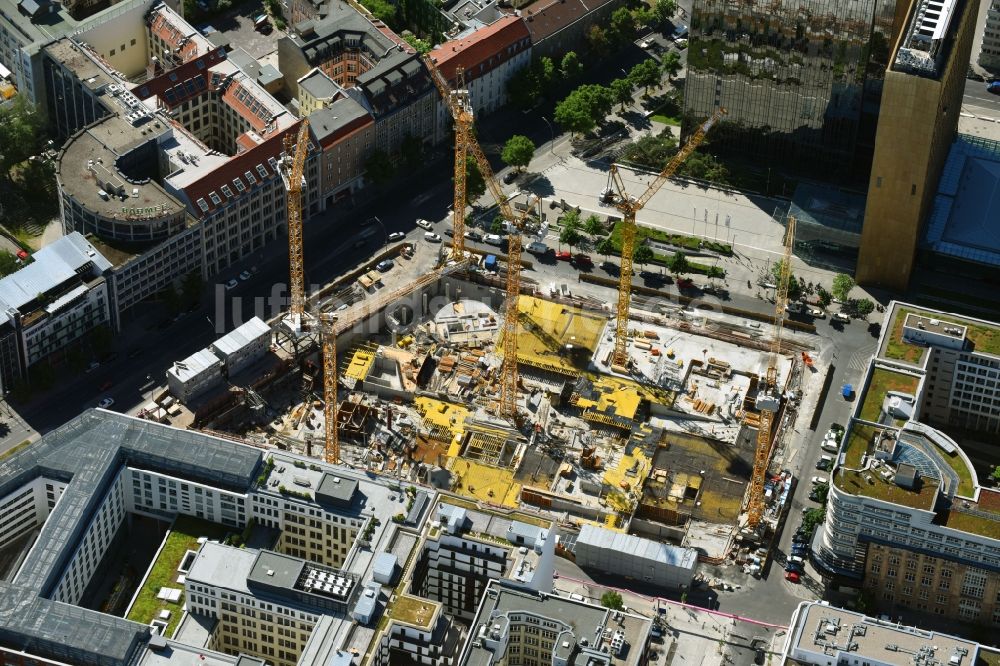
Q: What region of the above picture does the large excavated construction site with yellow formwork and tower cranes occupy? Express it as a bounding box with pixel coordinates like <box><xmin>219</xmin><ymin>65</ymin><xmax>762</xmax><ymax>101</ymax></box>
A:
<box><xmin>146</xmin><ymin>63</ymin><xmax>816</xmax><ymax>563</ymax></box>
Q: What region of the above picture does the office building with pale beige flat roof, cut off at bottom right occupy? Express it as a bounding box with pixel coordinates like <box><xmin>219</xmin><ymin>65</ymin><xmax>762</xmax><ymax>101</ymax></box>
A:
<box><xmin>782</xmin><ymin>601</ymin><xmax>998</xmax><ymax>666</ymax></box>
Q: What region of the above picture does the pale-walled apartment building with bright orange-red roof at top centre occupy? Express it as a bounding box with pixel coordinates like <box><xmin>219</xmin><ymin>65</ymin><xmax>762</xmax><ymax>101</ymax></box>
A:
<box><xmin>429</xmin><ymin>16</ymin><xmax>531</xmax><ymax>141</ymax></box>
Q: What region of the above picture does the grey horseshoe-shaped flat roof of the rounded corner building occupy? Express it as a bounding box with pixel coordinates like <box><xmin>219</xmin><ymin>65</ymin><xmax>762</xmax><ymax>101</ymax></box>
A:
<box><xmin>57</xmin><ymin>113</ymin><xmax>184</xmax><ymax>218</ymax></box>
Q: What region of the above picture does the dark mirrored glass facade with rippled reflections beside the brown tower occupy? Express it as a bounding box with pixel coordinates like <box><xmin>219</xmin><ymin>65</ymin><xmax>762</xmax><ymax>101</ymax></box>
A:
<box><xmin>684</xmin><ymin>0</ymin><xmax>896</xmax><ymax>182</ymax></box>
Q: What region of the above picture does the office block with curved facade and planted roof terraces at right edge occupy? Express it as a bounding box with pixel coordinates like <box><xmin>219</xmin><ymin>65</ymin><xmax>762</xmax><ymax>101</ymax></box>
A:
<box><xmin>813</xmin><ymin>302</ymin><xmax>1000</xmax><ymax>625</ymax></box>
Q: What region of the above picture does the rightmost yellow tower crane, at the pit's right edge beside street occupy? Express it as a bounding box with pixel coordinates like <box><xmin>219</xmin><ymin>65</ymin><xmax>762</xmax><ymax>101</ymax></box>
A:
<box><xmin>747</xmin><ymin>216</ymin><xmax>795</xmax><ymax>529</ymax></box>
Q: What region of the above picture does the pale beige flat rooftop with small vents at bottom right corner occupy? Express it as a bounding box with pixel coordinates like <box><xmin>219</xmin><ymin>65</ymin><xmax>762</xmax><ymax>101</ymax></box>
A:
<box><xmin>790</xmin><ymin>603</ymin><xmax>979</xmax><ymax>666</ymax></box>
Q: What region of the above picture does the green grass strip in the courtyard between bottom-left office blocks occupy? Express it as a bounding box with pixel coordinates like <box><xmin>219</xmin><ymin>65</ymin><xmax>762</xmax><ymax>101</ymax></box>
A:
<box><xmin>126</xmin><ymin>516</ymin><xmax>234</xmax><ymax>637</ymax></box>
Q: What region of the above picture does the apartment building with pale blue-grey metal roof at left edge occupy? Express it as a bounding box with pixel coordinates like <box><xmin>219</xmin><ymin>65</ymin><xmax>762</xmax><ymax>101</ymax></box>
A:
<box><xmin>0</xmin><ymin>233</ymin><xmax>118</xmax><ymax>391</ymax></box>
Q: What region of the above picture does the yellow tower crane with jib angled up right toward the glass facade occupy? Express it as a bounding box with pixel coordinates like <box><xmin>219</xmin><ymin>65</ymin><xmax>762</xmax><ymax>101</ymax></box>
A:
<box><xmin>604</xmin><ymin>108</ymin><xmax>726</xmax><ymax>371</ymax></box>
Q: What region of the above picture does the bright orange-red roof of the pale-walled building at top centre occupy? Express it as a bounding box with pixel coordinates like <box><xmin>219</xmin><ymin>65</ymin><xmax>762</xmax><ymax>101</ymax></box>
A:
<box><xmin>430</xmin><ymin>16</ymin><xmax>530</xmax><ymax>81</ymax></box>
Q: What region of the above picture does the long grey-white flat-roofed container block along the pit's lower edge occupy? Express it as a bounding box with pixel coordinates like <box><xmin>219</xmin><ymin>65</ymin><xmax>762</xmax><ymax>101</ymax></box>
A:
<box><xmin>573</xmin><ymin>525</ymin><xmax>698</xmax><ymax>590</ymax></box>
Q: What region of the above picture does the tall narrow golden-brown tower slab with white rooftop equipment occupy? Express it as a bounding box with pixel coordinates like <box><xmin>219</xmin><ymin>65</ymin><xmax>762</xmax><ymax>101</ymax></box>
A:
<box><xmin>856</xmin><ymin>0</ymin><xmax>976</xmax><ymax>291</ymax></box>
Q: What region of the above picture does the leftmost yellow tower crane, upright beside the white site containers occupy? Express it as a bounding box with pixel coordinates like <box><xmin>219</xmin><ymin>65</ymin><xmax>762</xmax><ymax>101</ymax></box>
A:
<box><xmin>281</xmin><ymin>119</ymin><xmax>309</xmax><ymax>332</ymax></box>
